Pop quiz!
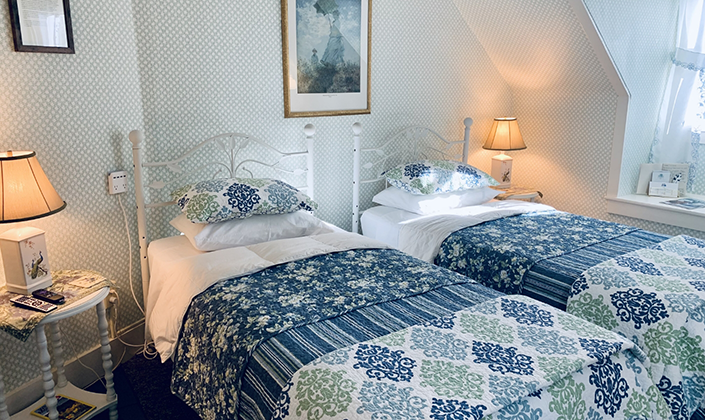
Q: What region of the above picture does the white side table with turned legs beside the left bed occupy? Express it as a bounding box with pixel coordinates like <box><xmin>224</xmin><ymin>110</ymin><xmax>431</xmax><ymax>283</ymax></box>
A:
<box><xmin>0</xmin><ymin>287</ymin><xmax>118</xmax><ymax>420</ymax></box>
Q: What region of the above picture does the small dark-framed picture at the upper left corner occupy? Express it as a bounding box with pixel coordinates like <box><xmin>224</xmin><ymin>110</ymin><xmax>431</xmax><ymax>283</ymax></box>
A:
<box><xmin>9</xmin><ymin>0</ymin><xmax>75</xmax><ymax>54</ymax></box>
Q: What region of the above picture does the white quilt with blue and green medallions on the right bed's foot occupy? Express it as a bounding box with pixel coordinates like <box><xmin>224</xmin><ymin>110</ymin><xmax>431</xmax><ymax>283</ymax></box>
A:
<box><xmin>568</xmin><ymin>236</ymin><xmax>705</xmax><ymax>420</ymax></box>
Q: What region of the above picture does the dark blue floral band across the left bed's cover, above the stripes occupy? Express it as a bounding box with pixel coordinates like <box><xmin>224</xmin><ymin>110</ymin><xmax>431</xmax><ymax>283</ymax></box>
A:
<box><xmin>172</xmin><ymin>249</ymin><xmax>478</xmax><ymax>419</ymax></box>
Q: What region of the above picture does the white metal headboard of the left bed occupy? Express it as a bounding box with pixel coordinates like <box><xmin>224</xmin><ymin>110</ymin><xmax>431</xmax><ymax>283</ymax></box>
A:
<box><xmin>130</xmin><ymin>124</ymin><xmax>316</xmax><ymax>305</ymax></box>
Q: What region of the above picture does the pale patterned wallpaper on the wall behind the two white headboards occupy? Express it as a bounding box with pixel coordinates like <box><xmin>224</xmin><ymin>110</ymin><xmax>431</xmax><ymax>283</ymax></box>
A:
<box><xmin>134</xmin><ymin>0</ymin><xmax>512</xmax><ymax>234</ymax></box>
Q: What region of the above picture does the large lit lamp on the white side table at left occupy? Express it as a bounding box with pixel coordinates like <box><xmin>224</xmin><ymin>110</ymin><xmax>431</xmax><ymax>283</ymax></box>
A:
<box><xmin>0</xmin><ymin>151</ymin><xmax>66</xmax><ymax>295</ymax></box>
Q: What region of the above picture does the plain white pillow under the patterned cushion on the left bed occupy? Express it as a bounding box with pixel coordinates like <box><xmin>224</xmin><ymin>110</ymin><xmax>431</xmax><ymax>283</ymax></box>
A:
<box><xmin>169</xmin><ymin>211</ymin><xmax>333</xmax><ymax>251</ymax></box>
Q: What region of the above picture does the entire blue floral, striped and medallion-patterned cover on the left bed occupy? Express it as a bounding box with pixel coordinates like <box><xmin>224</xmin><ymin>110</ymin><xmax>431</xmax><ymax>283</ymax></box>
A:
<box><xmin>172</xmin><ymin>249</ymin><xmax>668</xmax><ymax>420</ymax></box>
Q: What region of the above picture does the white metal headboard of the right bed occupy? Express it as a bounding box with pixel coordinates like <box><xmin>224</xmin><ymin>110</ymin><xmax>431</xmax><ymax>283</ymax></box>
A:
<box><xmin>352</xmin><ymin>118</ymin><xmax>472</xmax><ymax>233</ymax></box>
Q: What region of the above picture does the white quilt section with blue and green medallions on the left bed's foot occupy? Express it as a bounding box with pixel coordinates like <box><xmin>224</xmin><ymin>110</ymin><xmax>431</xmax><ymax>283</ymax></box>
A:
<box><xmin>275</xmin><ymin>296</ymin><xmax>669</xmax><ymax>420</ymax></box>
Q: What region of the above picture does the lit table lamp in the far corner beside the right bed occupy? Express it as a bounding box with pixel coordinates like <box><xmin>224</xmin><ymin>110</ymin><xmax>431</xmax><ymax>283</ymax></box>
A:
<box><xmin>482</xmin><ymin>117</ymin><xmax>526</xmax><ymax>187</ymax></box>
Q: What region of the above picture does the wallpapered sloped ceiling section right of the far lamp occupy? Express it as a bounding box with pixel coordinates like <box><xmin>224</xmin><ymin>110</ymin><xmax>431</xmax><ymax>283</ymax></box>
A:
<box><xmin>453</xmin><ymin>0</ymin><xmax>618</xmax><ymax>219</ymax></box>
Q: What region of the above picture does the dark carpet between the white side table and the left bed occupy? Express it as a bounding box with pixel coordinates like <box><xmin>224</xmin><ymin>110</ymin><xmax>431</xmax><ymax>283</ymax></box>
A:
<box><xmin>87</xmin><ymin>356</ymin><xmax>200</xmax><ymax>420</ymax></box>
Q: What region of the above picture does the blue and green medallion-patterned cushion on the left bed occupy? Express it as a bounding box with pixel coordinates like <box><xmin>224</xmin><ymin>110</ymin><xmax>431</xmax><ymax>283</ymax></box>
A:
<box><xmin>171</xmin><ymin>178</ymin><xmax>318</xmax><ymax>223</ymax></box>
